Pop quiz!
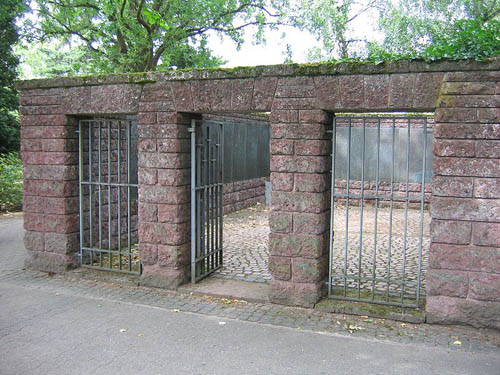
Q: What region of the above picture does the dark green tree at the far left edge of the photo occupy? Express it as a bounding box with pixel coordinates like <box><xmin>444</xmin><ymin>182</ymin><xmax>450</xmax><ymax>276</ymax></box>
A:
<box><xmin>0</xmin><ymin>0</ymin><xmax>23</xmax><ymax>152</ymax></box>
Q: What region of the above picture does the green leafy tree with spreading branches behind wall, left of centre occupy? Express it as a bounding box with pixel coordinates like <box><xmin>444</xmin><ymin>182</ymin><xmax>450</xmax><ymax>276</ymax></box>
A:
<box><xmin>26</xmin><ymin>0</ymin><xmax>286</xmax><ymax>72</ymax></box>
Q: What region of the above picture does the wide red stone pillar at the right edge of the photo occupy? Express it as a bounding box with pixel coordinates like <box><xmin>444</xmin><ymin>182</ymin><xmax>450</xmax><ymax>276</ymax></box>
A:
<box><xmin>426</xmin><ymin>72</ymin><xmax>500</xmax><ymax>329</ymax></box>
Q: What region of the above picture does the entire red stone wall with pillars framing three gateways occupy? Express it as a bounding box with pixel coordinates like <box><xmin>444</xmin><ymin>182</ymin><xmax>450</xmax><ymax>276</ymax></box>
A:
<box><xmin>18</xmin><ymin>60</ymin><xmax>500</xmax><ymax>328</ymax></box>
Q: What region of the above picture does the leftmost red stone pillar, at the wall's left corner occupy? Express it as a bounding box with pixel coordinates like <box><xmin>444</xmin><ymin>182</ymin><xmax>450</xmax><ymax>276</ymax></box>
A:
<box><xmin>20</xmin><ymin>88</ymin><xmax>79</xmax><ymax>272</ymax></box>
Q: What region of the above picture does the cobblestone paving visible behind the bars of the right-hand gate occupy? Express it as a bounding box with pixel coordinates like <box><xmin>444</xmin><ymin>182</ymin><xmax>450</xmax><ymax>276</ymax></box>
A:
<box><xmin>333</xmin><ymin>206</ymin><xmax>430</xmax><ymax>298</ymax></box>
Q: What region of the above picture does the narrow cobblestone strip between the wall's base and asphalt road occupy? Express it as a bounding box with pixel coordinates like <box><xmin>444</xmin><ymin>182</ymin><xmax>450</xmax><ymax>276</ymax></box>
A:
<box><xmin>0</xmin><ymin>270</ymin><xmax>500</xmax><ymax>355</ymax></box>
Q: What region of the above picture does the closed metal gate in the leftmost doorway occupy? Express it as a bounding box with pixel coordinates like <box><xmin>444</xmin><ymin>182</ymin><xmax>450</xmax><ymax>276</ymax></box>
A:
<box><xmin>78</xmin><ymin>118</ymin><xmax>142</xmax><ymax>274</ymax></box>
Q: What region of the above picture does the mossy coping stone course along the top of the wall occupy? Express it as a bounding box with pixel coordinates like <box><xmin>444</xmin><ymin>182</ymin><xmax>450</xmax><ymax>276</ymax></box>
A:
<box><xmin>16</xmin><ymin>58</ymin><xmax>500</xmax><ymax>91</ymax></box>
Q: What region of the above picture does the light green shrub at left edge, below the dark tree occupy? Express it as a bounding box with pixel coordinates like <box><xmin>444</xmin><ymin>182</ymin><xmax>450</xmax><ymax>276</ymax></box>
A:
<box><xmin>0</xmin><ymin>152</ymin><xmax>23</xmax><ymax>211</ymax></box>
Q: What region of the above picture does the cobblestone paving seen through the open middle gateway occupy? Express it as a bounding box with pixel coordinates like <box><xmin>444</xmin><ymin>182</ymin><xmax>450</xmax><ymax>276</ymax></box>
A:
<box><xmin>214</xmin><ymin>203</ymin><xmax>271</xmax><ymax>282</ymax></box>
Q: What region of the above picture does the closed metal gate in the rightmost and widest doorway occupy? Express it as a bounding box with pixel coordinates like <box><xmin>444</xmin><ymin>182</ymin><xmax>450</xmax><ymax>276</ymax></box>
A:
<box><xmin>328</xmin><ymin>117</ymin><xmax>432</xmax><ymax>308</ymax></box>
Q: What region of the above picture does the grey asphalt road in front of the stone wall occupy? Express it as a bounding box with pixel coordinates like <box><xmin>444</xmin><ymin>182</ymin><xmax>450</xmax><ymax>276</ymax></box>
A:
<box><xmin>0</xmin><ymin>214</ymin><xmax>500</xmax><ymax>375</ymax></box>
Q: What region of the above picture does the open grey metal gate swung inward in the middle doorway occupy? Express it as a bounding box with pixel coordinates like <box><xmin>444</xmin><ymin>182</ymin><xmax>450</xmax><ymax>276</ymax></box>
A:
<box><xmin>190</xmin><ymin>120</ymin><xmax>224</xmax><ymax>283</ymax></box>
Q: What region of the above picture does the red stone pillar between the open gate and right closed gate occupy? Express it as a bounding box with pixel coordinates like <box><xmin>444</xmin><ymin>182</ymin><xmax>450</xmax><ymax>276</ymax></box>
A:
<box><xmin>269</xmin><ymin>77</ymin><xmax>331</xmax><ymax>307</ymax></box>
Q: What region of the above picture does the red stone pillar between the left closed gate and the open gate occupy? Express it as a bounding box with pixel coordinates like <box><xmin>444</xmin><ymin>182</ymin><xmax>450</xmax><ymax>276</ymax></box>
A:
<box><xmin>137</xmin><ymin>90</ymin><xmax>191</xmax><ymax>289</ymax></box>
